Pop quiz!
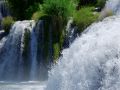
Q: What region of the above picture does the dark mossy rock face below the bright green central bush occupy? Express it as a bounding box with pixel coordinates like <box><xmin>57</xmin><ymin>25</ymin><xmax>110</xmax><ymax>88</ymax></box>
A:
<box><xmin>38</xmin><ymin>15</ymin><xmax>64</xmax><ymax>64</ymax></box>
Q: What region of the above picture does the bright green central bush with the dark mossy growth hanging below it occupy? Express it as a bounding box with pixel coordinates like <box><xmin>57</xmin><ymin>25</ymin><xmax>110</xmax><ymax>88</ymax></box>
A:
<box><xmin>42</xmin><ymin>0</ymin><xmax>75</xmax><ymax>62</ymax></box>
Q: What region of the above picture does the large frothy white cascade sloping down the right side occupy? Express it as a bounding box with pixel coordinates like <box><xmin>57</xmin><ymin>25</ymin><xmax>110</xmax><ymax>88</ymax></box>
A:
<box><xmin>46</xmin><ymin>0</ymin><xmax>120</xmax><ymax>90</ymax></box>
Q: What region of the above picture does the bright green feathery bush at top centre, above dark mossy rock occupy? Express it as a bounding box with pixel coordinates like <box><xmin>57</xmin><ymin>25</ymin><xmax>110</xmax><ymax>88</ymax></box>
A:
<box><xmin>43</xmin><ymin>0</ymin><xmax>74</xmax><ymax>19</ymax></box>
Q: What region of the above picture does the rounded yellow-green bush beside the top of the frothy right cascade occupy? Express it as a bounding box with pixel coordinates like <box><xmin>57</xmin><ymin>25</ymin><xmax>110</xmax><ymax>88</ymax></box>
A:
<box><xmin>73</xmin><ymin>7</ymin><xmax>99</xmax><ymax>32</ymax></box>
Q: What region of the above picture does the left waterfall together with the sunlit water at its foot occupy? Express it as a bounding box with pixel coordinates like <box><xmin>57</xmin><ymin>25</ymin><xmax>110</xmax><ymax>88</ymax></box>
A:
<box><xmin>0</xmin><ymin>20</ymin><xmax>47</xmax><ymax>90</ymax></box>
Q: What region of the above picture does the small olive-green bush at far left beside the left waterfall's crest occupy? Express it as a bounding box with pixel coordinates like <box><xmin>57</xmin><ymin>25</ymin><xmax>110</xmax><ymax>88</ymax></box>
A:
<box><xmin>1</xmin><ymin>16</ymin><xmax>14</xmax><ymax>33</ymax></box>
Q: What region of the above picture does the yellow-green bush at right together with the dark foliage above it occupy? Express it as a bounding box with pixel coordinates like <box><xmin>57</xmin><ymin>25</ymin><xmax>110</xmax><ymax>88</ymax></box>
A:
<box><xmin>73</xmin><ymin>0</ymin><xmax>106</xmax><ymax>33</ymax></box>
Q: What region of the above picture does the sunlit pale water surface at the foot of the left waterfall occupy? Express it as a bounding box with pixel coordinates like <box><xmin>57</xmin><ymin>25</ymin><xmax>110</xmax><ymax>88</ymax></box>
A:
<box><xmin>0</xmin><ymin>81</ymin><xmax>46</xmax><ymax>90</ymax></box>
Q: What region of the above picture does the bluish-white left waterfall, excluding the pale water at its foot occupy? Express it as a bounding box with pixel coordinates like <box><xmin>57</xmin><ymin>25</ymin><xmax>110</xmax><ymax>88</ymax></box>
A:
<box><xmin>0</xmin><ymin>20</ymin><xmax>50</xmax><ymax>81</ymax></box>
